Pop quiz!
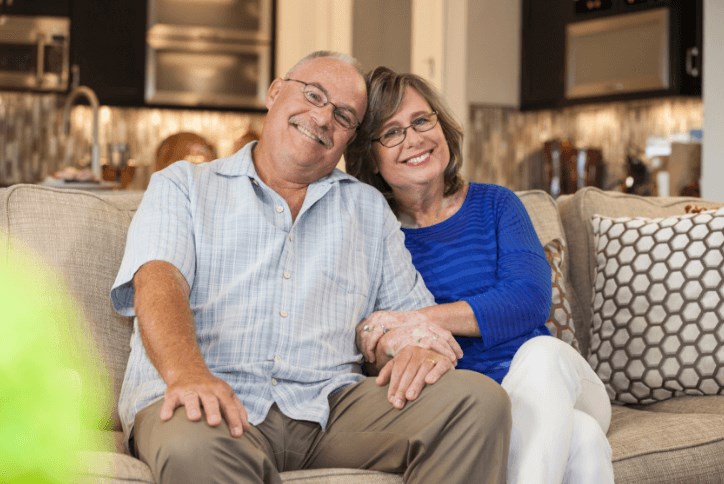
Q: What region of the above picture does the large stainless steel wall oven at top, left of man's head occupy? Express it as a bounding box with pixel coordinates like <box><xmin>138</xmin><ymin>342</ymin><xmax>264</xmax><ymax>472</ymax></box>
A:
<box><xmin>145</xmin><ymin>0</ymin><xmax>272</xmax><ymax>109</ymax></box>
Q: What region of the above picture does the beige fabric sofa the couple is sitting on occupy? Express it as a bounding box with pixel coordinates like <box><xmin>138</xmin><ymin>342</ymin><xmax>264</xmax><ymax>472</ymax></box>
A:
<box><xmin>0</xmin><ymin>185</ymin><xmax>724</xmax><ymax>484</ymax></box>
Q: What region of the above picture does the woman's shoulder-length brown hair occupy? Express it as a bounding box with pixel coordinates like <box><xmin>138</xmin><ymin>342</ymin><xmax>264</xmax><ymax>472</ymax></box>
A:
<box><xmin>344</xmin><ymin>66</ymin><xmax>463</xmax><ymax>203</ymax></box>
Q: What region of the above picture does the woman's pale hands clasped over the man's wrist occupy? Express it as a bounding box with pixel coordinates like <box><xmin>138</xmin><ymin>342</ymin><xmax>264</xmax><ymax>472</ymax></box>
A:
<box><xmin>357</xmin><ymin>311</ymin><xmax>463</xmax><ymax>365</ymax></box>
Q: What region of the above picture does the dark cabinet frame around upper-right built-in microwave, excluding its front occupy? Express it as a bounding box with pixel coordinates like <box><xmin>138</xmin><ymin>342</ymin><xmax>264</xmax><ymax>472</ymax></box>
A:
<box><xmin>520</xmin><ymin>0</ymin><xmax>703</xmax><ymax>110</ymax></box>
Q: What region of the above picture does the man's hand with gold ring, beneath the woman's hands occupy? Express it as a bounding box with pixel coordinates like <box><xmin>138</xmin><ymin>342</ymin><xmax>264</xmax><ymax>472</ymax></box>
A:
<box><xmin>376</xmin><ymin>346</ymin><xmax>454</xmax><ymax>409</ymax></box>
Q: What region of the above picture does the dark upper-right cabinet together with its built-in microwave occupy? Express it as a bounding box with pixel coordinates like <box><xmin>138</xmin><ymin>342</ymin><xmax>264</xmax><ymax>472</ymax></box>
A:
<box><xmin>521</xmin><ymin>0</ymin><xmax>702</xmax><ymax>109</ymax></box>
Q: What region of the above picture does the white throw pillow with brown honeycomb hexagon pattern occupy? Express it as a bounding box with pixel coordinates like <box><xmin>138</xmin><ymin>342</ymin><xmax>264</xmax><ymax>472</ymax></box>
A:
<box><xmin>589</xmin><ymin>209</ymin><xmax>724</xmax><ymax>403</ymax></box>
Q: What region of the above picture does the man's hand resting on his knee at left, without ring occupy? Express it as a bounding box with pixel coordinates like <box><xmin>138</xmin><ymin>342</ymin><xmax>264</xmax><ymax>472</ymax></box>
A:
<box><xmin>161</xmin><ymin>373</ymin><xmax>249</xmax><ymax>437</ymax></box>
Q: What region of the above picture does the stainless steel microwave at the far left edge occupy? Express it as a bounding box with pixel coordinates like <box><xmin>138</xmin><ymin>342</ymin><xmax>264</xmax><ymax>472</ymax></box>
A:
<box><xmin>0</xmin><ymin>15</ymin><xmax>70</xmax><ymax>91</ymax></box>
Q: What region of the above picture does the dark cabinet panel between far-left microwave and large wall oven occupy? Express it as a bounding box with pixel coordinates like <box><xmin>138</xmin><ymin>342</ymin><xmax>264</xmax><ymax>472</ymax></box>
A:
<box><xmin>71</xmin><ymin>0</ymin><xmax>147</xmax><ymax>106</ymax></box>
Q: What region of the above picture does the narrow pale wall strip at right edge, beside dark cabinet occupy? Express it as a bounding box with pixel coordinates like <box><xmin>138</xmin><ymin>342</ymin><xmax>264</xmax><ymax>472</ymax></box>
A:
<box><xmin>701</xmin><ymin>0</ymin><xmax>724</xmax><ymax>201</ymax></box>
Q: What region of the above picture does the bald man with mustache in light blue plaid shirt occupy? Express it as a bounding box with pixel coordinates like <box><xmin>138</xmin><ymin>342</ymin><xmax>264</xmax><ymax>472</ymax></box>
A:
<box><xmin>112</xmin><ymin>52</ymin><xmax>510</xmax><ymax>483</ymax></box>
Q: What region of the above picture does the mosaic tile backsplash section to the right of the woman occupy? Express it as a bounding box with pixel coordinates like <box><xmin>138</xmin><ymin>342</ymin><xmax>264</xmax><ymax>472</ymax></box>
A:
<box><xmin>470</xmin><ymin>98</ymin><xmax>706</xmax><ymax>190</ymax></box>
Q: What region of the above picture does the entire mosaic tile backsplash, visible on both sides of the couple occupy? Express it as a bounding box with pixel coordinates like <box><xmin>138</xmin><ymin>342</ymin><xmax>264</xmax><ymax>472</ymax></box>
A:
<box><xmin>0</xmin><ymin>92</ymin><xmax>703</xmax><ymax>190</ymax></box>
